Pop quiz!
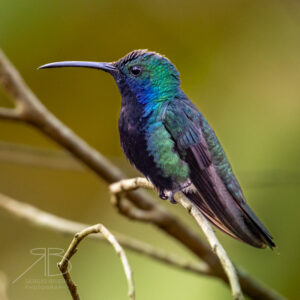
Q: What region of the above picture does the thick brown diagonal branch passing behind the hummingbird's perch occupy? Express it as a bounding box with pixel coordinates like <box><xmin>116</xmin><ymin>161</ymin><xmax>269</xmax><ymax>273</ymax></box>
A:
<box><xmin>0</xmin><ymin>51</ymin><xmax>280</xmax><ymax>299</ymax></box>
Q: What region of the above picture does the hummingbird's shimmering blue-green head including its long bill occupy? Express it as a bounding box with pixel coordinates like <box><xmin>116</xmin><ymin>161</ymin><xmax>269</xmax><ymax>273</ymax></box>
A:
<box><xmin>40</xmin><ymin>50</ymin><xmax>180</xmax><ymax>104</ymax></box>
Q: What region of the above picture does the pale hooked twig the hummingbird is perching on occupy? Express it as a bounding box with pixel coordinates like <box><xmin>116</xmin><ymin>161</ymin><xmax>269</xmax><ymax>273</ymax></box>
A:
<box><xmin>110</xmin><ymin>178</ymin><xmax>244</xmax><ymax>300</ymax></box>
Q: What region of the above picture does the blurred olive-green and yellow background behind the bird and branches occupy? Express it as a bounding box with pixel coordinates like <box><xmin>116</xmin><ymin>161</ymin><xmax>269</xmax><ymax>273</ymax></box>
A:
<box><xmin>0</xmin><ymin>0</ymin><xmax>300</xmax><ymax>300</ymax></box>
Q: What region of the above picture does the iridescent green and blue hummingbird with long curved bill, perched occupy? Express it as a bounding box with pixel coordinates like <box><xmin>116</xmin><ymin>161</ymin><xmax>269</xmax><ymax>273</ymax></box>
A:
<box><xmin>40</xmin><ymin>50</ymin><xmax>275</xmax><ymax>248</ymax></box>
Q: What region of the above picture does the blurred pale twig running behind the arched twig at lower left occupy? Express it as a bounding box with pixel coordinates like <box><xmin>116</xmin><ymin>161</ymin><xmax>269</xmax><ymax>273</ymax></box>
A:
<box><xmin>0</xmin><ymin>194</ymin><xmax>210</xmax><ymax>275</ymax></box>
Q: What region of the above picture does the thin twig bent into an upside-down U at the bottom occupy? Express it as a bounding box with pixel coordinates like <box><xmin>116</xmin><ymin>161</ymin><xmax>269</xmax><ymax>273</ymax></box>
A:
<box><xmin>58</xmin><ymin>224</ymin><xmax>135</xmax><ymax>300</ymax></box>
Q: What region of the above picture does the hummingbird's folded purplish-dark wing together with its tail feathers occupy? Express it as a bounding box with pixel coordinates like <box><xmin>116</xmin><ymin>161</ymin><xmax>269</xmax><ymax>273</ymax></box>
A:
<box><xmin>164</xmin><ymin>100</ymin><xmax>275</xmax><ymax>247</ymax></box>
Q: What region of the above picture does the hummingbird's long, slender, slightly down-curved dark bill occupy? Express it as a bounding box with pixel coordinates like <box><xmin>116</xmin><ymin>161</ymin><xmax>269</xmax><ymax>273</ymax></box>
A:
<box><xmin>38</xmin><ymin>61</ymin><xmax>117</xmax><ymax>73</ymax></box>
